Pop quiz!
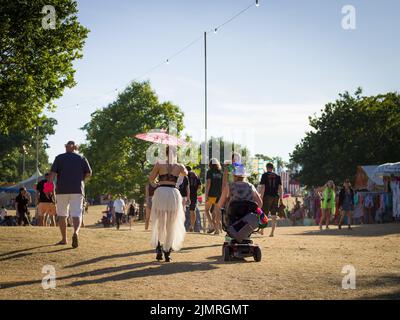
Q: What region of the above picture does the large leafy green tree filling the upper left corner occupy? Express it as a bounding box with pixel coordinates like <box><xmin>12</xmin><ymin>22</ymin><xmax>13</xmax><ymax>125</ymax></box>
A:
<box><xmin>0</xmin><ymin>0</ymin><xmax>88</xmax><ymax>134</ymax></box>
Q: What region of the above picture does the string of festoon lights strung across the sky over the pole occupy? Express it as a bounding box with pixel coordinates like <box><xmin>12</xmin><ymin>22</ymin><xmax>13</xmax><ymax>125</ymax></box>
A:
<box><xmin>59</xmin><ymin>0</ymin><xmax>260</xmax><ymax>110</ymax></box>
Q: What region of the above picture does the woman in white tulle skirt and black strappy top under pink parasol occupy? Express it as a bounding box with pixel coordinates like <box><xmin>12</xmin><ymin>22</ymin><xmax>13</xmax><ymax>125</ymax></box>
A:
<box><xmin>149</xmin><ymin>152</ymin><xmax>187</xmax><ymax>262</ymax></box>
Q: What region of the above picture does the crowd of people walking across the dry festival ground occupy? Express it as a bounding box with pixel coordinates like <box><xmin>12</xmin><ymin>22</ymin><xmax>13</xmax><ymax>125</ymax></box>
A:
<box><xmin>0</xmin><ymin>141</ymin><xmax>390</xmax><ymax>262</ymax></box>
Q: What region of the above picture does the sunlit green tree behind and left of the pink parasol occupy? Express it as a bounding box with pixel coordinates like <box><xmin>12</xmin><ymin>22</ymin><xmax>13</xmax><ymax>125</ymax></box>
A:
<box><xmin>81</xmin><ymin>82</ymin><xmax>183</xmax><ymax>202</ymax></box>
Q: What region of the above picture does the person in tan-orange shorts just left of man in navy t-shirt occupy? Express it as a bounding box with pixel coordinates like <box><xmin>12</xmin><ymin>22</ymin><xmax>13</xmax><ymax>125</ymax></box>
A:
<box><xmin>36</xmin><ymin>173</ymin><xmax>56</xmax><ymax>227</ymax></box>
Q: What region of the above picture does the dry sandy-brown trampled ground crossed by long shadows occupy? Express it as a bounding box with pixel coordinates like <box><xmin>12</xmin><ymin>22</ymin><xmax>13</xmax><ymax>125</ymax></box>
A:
<box><xmin>0</xmin><ymin>207</ymin><xmax>400</xmax><ymax>299</ymax></box>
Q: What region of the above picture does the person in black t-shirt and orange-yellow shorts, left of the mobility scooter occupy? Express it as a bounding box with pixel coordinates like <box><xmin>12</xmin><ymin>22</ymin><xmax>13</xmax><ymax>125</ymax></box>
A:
<box><xmin>205</xmin><ymin>158</ymin><xmax>223</xmax><ymax>234</ymax></box>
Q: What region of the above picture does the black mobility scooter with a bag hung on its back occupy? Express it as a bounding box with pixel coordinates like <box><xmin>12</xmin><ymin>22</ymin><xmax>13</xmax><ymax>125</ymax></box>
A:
<box><xmin>222</xmin><ymin>200</ymin><xmax>261</xmax><ymax>262</ymax></box>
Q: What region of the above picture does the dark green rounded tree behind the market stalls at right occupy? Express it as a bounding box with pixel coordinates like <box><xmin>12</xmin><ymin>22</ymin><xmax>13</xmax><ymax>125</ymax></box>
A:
<box><xmin>291</xmin><ymin>88</ymin><xmax>400</xmax><ymax>186</ymax></box>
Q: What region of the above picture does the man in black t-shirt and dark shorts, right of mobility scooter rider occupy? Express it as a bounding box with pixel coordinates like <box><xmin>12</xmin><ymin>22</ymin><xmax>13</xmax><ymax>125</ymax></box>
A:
<box><xmin>260</xmin><ymin>163</ymin><xmax>283</xmax><ymax>237</ymax></box>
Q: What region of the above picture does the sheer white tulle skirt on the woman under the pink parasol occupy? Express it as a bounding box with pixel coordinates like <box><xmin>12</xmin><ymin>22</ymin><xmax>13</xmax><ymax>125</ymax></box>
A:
<box><xmin>150</xmin><ymin>187</ymin><xmax>186</xmax><ymax>251</ymax></box>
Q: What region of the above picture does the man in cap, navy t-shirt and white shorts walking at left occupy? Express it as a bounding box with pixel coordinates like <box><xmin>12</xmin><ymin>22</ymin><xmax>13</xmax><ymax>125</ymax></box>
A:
<box><xmin>49</xmin><ymin>141</ymin><xmax>92</xmax><ymax>248</ymax></box>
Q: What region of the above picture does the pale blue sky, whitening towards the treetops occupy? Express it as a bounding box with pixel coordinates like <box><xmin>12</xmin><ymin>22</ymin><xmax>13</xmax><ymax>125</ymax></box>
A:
<box><xmin>46</xmin><ymin>0</ymin><xmax>400</xmax><ymax>161</ymax></box>
